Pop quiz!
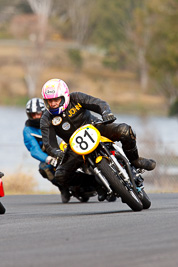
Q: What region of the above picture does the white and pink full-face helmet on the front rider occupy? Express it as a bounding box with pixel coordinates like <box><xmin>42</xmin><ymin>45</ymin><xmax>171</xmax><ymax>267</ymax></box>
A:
<box><xmin>42</xmin><ymin>79</ymin><xmax>70</xmax><ymax>115</ymax></box>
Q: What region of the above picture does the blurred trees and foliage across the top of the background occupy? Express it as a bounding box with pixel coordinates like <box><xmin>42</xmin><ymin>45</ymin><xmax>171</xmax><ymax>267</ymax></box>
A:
<box><xmin>0</xmin><ymin>0</ymin><xmax>178</xmax><ymax>114</ymax></box>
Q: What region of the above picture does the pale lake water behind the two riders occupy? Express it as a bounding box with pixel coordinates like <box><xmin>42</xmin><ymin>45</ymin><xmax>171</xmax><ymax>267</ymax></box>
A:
<box><xmin>0</xmin><ymin>106</ymin><xmax>178</xmax><ymax>190</ymax></box>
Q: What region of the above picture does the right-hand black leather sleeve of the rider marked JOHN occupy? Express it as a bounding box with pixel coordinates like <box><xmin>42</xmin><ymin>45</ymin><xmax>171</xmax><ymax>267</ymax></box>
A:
<box><xmin>71</xmin><ymin>92</ymin><xmax>111</xmax><ymax>115</ymax></box>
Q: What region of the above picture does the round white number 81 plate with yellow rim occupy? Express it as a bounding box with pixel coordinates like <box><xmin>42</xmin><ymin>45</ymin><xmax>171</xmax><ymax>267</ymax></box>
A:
<box><xmin>69</xmin><ymin>124</ymin><xmax>101</xmax><ymax>155</ymax></box>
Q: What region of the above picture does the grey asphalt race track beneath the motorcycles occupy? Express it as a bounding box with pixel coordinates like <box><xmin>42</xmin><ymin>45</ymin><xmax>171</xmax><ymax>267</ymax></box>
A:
<box><xmin>0</xmin><ymin>194</ymin><xmax>178</xmax><ymax>267</ymax></box>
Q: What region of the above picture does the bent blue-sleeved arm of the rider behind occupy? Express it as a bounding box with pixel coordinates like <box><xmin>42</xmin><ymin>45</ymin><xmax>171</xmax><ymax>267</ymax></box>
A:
<box><xmin>23</xmin><ymin>127</ymin><xmax>48</xmax><ymax>162</ymax></box>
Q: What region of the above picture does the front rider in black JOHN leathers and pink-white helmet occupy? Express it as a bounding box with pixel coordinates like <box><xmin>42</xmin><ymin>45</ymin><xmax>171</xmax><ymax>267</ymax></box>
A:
<box><xmin>40</xmin><ymin>79</ymin><xmax>156</xmax><ymax>202</ymax></box>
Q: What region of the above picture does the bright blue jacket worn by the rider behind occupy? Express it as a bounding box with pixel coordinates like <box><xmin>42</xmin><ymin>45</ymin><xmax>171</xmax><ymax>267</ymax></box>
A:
<box><xmin>23</xmin><ymin>123</ymin><xmax>48</xmax><ymax>162</ymax></box>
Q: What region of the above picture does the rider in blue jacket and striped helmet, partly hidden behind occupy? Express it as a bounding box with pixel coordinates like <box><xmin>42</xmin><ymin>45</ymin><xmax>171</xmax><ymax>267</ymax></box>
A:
<box><xmin>23</xmin><ymin>98</ymin><xmax>59</xmax><ymax>193</ymax></box>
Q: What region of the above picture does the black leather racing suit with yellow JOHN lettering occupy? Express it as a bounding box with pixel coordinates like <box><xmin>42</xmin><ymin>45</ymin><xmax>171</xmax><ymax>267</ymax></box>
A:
<box><xmin>40</xmin><ymin>92</ymin><xmax>136</xmax><ymax>185</ymax></box>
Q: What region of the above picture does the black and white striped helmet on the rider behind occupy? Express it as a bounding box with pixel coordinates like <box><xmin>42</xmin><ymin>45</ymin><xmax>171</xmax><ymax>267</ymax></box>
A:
<box><xmin>26</xmin><ymin>98</ymin><xmax>45</xmax><ymax>120</ymax></box>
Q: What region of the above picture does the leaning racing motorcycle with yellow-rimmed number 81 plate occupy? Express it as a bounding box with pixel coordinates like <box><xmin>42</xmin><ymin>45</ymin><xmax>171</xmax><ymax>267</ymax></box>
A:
<box><xmin>61</xmin><ymin>120</ymin><xmax>151</xmax><ymax>211</ymax></box>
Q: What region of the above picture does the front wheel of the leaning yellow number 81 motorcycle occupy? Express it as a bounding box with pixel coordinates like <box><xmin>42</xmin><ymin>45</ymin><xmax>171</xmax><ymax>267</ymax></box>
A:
<box><xmin>98</xmin><ymin>158</ymin><xmax>143</xmax><ymax>211</ymax></box>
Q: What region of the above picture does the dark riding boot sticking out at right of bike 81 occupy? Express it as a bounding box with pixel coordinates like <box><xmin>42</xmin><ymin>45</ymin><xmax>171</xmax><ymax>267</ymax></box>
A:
<box><xmin>124</xmin><ymin>146</ymin><xmax>156</xmax><ymax>171</ymax></box>
